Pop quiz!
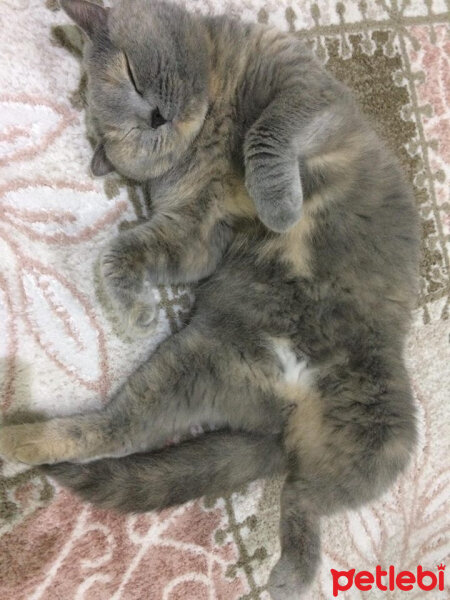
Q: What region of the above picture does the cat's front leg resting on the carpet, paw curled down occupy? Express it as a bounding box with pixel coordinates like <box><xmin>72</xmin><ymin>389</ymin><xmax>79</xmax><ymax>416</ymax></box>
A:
<box><xmin>100</xmin><ymin>200</ymin><xmax>232</xmax><ymax>335</ymax></box>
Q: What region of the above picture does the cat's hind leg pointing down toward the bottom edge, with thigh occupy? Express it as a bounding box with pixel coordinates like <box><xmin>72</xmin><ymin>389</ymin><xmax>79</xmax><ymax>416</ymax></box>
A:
<box><xmin>269</xmin><ymin>346</ymin><xmax>416</xmax><ymax>600</ymax></box>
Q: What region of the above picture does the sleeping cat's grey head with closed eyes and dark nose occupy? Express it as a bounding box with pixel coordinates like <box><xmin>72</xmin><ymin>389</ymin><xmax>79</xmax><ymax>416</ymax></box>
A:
<box><xmin>61</xmin><ymin>0</ymin><xmax>208</xmax><ymax>181</ymax></box>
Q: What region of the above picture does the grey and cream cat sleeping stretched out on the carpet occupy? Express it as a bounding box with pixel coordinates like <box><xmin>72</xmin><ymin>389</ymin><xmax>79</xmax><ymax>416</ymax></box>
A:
<box><xmin>0</xmin><ymin>0</ymin><xmax>418</xmax><ymax>600</ymax></box>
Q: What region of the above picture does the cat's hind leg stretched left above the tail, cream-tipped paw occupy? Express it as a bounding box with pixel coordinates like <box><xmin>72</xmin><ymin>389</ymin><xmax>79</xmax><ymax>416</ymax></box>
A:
<box><xmin>0</xmin><ymin>323</ymin><xmax>285</xmax><ymax>464</ymax></box>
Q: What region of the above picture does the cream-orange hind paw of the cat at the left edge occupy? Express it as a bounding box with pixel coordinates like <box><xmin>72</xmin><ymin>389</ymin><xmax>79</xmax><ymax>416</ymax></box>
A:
<box><xmin>0</xmin><ymin>421</ymin><xmax>75</xmax><ymax>465</ymax></box>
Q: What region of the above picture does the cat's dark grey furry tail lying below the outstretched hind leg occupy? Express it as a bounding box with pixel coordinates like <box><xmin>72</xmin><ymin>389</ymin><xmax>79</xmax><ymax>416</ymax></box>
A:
<box><xmin>42</xmin><ymin>432</ymin><xmax>286</xmax><ymax>512</ymax></box>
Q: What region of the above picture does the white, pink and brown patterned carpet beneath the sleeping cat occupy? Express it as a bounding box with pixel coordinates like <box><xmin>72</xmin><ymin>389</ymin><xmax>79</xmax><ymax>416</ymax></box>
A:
<box><xmin>0</xmin><ymin>0</ymin><xmax>450</xmax><ymax>600</ymax></box>
